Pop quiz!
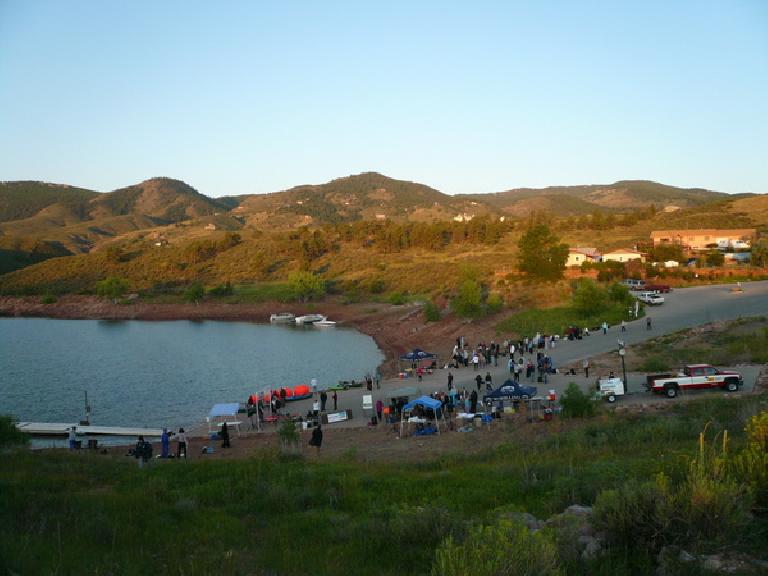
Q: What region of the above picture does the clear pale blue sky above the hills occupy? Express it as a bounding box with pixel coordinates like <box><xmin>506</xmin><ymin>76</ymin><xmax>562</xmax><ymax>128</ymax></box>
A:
<box><xmin>0</xmin><ymin>0</ymin><xmax>768</xmax><ymax>196</ymax></box>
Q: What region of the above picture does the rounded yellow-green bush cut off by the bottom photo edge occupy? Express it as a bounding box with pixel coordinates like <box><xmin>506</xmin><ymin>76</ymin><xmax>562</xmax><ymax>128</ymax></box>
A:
<box><xmin>432</xmin><ymin>520</ymin><xmax>562</xmax><ymax>576</ymax></box>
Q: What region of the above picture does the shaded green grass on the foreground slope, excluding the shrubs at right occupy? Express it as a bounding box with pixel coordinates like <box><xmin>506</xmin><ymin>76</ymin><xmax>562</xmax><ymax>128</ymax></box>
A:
<box><xmin>0</xmin><ymin>398</ymin><xmax>768</xmax><ymax>574</ymax></box>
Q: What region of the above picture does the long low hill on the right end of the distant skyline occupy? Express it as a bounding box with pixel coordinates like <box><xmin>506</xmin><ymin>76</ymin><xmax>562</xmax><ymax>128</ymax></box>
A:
<box><xmin>461</xmin><ymin>180</ymin><xmax>732</xmax><ymax>216</ymax></box>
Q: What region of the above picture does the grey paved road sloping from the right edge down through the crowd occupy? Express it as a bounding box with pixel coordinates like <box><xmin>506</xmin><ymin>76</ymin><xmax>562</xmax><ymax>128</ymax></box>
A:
<box><xmin>237</xmin><ymin>281</ymin><xmax>768</xmax><ymax>427</ymax></box>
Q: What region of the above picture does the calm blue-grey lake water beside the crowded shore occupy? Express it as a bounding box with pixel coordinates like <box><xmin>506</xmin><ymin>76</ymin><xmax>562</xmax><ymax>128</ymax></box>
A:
<box><xmin>0</xmin><ymin>318</ymin><xmax>383</xmax><ymax>428</ymax></box>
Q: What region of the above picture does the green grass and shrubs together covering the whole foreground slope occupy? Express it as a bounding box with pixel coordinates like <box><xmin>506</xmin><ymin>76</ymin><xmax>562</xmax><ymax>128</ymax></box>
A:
<box><xmin>0</xmin><ymin>396</ymin><xmax>768</xmax><ymax>575</ymax></box>
